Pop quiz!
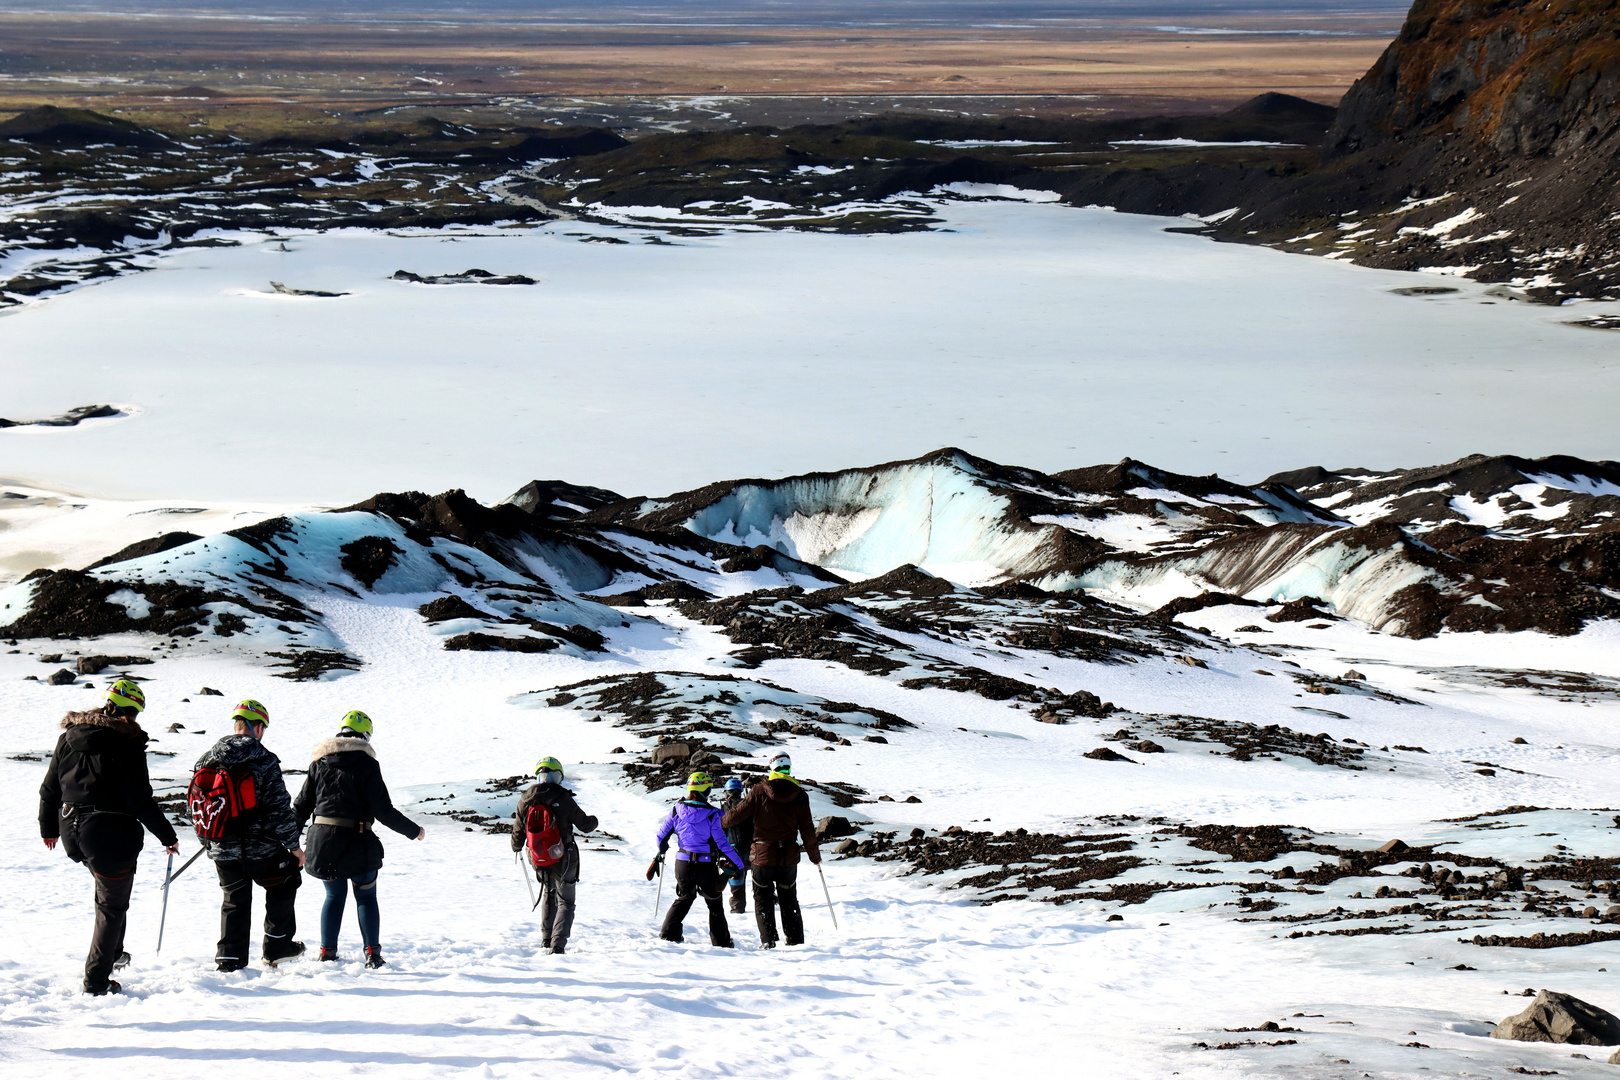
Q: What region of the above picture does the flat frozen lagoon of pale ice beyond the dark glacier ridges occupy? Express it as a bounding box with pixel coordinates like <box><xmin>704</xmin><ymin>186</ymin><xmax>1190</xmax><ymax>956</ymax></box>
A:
<box><xmin>0</xmin><ymin>202</ymin><xmax>1620</xmax><ymax>502</ymax></box>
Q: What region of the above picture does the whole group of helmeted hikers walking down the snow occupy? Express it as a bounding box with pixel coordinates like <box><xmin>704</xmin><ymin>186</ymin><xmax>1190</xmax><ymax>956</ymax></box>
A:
<box><xmin>39</xmin><ymin>678</ymin><xmax>821</xmax><ymax>996</ymax></box>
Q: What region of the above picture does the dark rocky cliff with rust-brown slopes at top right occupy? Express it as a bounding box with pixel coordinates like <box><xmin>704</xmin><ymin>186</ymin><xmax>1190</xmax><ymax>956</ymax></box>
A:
<box><xmin>1218</xmin><ymin>0</ymin><xmax>1620</xmax><ymax>303</ymax></box>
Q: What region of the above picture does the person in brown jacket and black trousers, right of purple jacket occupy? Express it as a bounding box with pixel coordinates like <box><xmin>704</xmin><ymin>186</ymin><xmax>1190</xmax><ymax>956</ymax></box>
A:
<box><xmin>721</xmin><ymin>753</ymin><xmax>821</xmax><ymax>949</ymax></box>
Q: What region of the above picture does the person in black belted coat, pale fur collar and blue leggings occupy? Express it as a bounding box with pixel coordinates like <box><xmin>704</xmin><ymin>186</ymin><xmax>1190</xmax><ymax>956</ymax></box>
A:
<box><xmin>293</xmin><ymin>712</ymin><xmax>428</xmax><ymax>968</ymax></box>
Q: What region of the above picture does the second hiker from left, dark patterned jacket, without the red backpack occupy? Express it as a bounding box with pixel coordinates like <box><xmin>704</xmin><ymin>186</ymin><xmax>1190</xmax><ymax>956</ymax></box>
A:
<box><xmin>193</xmin><ymin>699</ymin><xmax>305</xmax><ymax>972</ymax></box>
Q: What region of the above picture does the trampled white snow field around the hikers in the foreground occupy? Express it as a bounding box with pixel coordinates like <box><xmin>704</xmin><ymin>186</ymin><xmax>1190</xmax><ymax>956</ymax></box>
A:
<box><xmin>0</xmin><ymin>573</ymin><xmax>1620</xmax><ymax>1077</ymax></box>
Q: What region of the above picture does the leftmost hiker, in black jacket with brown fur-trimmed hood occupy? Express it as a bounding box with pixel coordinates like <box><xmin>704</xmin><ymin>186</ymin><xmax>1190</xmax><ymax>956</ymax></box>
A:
<box><xmin>39</xmin><ymin>678</ymin><xmax>180</xmax><ymax>994</ymax></box>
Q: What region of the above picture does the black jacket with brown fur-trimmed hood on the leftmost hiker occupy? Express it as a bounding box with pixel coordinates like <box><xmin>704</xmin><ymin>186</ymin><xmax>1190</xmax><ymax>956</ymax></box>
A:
<box><xmin>39</xmin><ymin>709</ymin><xmax>178</xmax><ymax>847</ymax></box>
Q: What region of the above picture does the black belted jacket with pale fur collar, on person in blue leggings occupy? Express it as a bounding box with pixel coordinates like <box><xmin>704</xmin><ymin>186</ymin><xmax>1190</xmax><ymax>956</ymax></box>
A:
<box><xmin>293</xmin><ymin>735</ymin><xmax>420</xmax><ymax>881</ymax></box>
